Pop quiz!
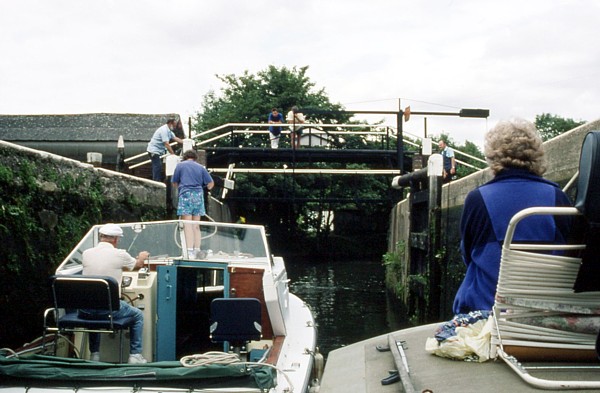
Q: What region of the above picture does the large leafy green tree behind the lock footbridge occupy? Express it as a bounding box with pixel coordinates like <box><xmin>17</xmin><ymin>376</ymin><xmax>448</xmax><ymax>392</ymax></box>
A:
<box><xmin>193</xmin><ymin>66</ymin><xmax>398</xmax><ymax>251</ymax></box>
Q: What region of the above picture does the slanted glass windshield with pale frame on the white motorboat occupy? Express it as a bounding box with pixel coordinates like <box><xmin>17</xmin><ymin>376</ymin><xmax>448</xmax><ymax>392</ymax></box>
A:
<box><xmin>56</xmin><ymin>220</ymin><xmax>270</xmax><ymax>274</ymax></box>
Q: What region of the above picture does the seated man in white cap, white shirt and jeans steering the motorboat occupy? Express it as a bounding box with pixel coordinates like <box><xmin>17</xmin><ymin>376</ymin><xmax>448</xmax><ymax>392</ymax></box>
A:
<box><xmin>82</xmin><ymin>224</ymin><xmax>150</xmax><ymax>363</ymax></box>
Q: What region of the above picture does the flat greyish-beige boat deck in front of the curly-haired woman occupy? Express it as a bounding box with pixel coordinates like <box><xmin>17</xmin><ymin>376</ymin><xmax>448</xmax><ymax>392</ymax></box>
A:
<box><xmin>319</xmin><ymin>324</ymin><xmax>600</xmax><ymax>393</ymax></box>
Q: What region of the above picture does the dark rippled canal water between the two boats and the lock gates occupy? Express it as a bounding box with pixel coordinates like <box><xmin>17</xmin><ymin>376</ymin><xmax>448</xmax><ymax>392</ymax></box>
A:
<box><xmin>285</xmin><ymin>257</ymin><xmax>410</xmax><ymax>356</ymax></box>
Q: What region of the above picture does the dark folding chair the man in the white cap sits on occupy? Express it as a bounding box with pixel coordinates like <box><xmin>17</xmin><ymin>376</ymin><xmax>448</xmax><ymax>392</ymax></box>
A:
<box><xmin>42</xmin><ymin>275</ymin><xmax>135</xmax><ymax>363</ymax></box>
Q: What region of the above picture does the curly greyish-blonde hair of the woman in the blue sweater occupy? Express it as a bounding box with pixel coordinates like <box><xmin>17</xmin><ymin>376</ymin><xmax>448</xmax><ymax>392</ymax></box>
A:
<box><xmin>484</xmin><ymin>119</ymin><xmax>546</xmax><ymax>176</ymax></box>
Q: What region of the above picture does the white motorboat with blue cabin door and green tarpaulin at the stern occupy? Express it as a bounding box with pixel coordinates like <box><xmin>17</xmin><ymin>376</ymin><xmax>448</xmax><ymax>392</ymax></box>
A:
<box><xmin>0</xmin><ymin>220</ymin><xmax>322</xmax><ymax>393</ymax></box>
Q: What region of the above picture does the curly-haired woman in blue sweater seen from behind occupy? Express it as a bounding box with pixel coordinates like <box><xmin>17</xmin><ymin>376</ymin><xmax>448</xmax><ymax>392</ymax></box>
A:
<box><xmin>453</xmin><ymin>119</ymin><xmax>571</xmax><ymax>314</ymax></box>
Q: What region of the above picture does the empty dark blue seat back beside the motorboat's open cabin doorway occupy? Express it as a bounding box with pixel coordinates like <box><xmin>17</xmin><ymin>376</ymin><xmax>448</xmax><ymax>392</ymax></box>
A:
<box><xmin>210</xmin><ymin>298</ymin><xmax>262</xmax><ymax>346</ymax></box>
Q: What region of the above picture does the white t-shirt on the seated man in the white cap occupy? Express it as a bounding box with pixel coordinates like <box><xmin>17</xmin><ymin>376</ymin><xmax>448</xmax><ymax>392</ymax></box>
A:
<box><xmin>82</xmin><ymin>242</ymin><xmax>136</xmax><ymax>288</ymax></box>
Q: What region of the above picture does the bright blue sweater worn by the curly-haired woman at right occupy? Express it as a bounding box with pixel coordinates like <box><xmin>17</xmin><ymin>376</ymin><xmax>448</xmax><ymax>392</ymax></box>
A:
<box><xmin>453</xmin><ymin>168</ymin><xmax>571</xmax><ymax>314</ymax></box>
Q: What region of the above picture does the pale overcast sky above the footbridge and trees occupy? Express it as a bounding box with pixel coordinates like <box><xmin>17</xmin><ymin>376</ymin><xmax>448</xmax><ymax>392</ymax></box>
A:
<box><xmin>0</xmin><ymin>0</ymin><xmax>600</xmax><ymax>146</ymax></box>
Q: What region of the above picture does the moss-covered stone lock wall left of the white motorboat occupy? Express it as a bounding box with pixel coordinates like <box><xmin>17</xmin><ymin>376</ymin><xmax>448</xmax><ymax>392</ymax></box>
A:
<box><xmin>0</xmin><ymin>146</ymin><xmax>165</xmax><ymax>348</ymax></box>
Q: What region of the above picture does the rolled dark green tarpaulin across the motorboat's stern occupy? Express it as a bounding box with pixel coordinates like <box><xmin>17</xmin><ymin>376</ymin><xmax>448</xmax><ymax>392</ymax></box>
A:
<box><xmin>0</xmin><ymin>355</ymin><xmax>277</xmax><ymax>389</ymax></box>
